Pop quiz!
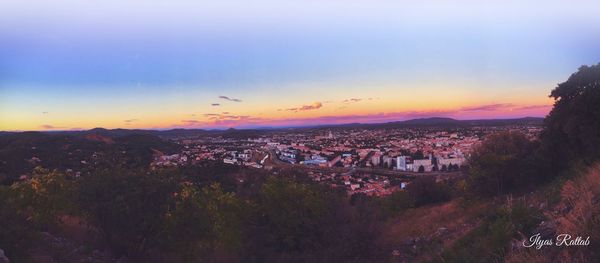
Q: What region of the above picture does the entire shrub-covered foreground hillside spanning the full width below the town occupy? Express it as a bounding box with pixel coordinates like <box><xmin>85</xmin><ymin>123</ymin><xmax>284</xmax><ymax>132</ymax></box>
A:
<box><xmin>0</xmin><ymin>161</ymin><xmax>600</xmax><ymax>262</ymax></box>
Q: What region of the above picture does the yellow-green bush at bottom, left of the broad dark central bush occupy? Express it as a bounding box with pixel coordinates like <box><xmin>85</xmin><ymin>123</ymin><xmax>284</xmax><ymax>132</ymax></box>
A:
<box><xmin>165</xmin><ymin>183</ymin><xmax>243</xmax><ymax>262</ymax></box>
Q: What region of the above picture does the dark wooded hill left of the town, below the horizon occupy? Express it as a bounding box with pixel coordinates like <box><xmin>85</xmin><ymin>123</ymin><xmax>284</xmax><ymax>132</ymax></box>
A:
<box><xmin>0</xmin><ymin>132</ymin><xmax>181</xmax><ymax>184</ymax></box>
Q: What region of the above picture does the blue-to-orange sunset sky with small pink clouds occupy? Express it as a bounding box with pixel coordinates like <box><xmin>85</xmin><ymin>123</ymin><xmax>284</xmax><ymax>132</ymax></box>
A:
<box><xmin>0</xmin><ymin>0</ymin><xmax>600</xmax><ymax>131</ymax></box>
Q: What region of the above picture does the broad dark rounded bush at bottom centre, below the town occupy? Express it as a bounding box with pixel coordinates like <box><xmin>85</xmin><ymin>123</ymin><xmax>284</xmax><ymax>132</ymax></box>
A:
<box><xmin>242</xmin><ymin>177</ymin><xmax>378</xmax><ymax>262</ymax></box>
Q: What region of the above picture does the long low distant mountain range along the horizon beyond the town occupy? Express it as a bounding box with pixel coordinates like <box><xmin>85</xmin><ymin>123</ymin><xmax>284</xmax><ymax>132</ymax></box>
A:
<box><xmin>0</xmin><ymin>117</ymin><xmax>544</xmax><ymax>138</ymax></box>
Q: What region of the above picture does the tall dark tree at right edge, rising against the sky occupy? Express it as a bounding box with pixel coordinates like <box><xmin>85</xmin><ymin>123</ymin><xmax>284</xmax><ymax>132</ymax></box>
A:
<box><xmin>541</xmin><ymin>63</ymin><xmax>600</xmax><ymax>172</ymax></box>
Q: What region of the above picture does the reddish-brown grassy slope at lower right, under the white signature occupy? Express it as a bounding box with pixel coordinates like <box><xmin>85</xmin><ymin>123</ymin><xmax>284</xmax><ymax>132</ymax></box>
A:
<box><xmin>380</xmin><ymin>164</ymin><xmax>600</xmax><ymax>262</ymax></box>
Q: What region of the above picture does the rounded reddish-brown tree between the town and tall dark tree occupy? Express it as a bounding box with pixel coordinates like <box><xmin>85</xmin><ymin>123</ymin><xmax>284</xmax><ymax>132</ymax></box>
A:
<box><xmin>469</xmin><ymin>132</ymin><xmax>537</xmax><ymax>198</ymax></box>
